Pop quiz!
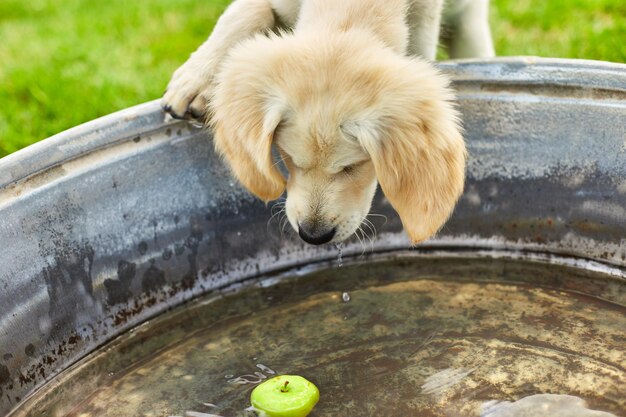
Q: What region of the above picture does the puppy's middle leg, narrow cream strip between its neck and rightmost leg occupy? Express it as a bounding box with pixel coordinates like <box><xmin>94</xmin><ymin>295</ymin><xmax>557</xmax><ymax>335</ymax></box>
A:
<box><xmin>407</xmin><ymin>0</ymin><xmax>443</xmax><ymax>61</ymax></box>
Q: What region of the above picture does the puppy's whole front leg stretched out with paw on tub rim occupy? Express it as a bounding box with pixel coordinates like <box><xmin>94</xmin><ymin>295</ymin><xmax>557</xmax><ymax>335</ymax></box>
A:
<box><xmin>161</xmin><ymin>0</ymin><xmax>275</xmax><ymax>118</ymax></box>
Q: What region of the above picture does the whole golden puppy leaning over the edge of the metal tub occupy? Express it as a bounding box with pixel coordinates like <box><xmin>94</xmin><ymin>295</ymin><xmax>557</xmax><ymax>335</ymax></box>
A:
<box><xmin>163</xmin><ymin>0</ymin><xmax>493</xmax><ymax>244</ymax></box>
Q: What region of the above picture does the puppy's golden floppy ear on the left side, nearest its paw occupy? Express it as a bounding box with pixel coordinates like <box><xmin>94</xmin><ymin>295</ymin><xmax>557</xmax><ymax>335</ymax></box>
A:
<box><xmin>209</xmin><ymin>35</ymin><xmax>285</xmax><ymax>202</ymax></box>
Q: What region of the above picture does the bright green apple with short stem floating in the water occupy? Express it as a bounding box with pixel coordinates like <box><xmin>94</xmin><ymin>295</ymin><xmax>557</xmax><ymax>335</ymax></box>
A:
<box><xmin>250</xmin><ymin>375</ymin><xmax>320</xmax><ymax>417</ymax></box>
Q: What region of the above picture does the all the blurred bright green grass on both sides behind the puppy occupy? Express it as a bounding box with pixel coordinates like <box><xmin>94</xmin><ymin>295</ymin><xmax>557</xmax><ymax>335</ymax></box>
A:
<box><xmin>0</xmin><ymin>0</ymin><xmax>626</xmax><ymax>157</ymax></box>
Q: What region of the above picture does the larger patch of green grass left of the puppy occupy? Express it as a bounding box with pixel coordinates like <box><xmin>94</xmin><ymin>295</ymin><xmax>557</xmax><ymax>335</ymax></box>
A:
<box><xmin>0</xmin><ymin>0</ymin><xmax>227</xmax><ymax>157</ymax></box>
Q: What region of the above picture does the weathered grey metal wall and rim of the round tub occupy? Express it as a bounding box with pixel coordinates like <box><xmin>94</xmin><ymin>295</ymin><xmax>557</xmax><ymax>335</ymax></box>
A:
<box><xmin>0</xmin><ymin>58</ymin><xmax>626</xmax><ymax>413</ymax></box>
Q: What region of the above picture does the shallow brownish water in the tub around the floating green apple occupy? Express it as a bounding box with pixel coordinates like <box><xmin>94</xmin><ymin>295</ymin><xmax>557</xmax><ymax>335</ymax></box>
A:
<box><xmin>14</xmin><ymin>258</ymin><xmax>626</xmax><ymax>417</ymax></box>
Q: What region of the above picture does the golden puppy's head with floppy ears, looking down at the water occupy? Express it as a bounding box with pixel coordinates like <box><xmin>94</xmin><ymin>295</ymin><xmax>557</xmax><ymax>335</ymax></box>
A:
<box><xmin>210</xmin><ymin>31</ymin><xmax>465</xmax><ymax>244</ymax></box>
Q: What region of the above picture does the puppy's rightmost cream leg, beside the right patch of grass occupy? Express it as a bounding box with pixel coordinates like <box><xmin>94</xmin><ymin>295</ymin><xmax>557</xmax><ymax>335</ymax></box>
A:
<box><xmin>446</xmin><ymin>0</ymin><xmax>495</xmax><ymax>58</ymax></box>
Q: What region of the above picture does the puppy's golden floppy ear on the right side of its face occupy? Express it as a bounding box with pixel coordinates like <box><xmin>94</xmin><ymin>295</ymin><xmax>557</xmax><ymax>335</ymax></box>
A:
<box><xmin>344</xmin><ymin>58</ymin><xmax>466</xmax><ymax>244</ymax></box>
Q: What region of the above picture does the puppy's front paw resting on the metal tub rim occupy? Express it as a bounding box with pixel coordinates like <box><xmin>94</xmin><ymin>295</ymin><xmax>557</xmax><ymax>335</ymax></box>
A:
<box><xmin>161</xmin><ymin>61</ymin><xmax>213</xmax><ymax>120</ymax></box>
